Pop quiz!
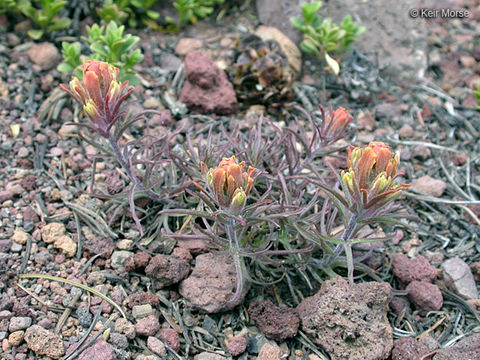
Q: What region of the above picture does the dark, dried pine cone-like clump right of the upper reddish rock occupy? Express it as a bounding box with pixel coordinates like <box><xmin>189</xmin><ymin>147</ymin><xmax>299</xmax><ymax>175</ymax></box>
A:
<box><xmin>233</xmin><ymin>35</ymin><xmax>294</xmax><ymax>106</ymax></box>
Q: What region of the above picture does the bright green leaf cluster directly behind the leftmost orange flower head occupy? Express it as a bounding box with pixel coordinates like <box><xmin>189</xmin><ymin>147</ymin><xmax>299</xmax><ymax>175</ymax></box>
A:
<box><xmin>57</xmin><ymin>21</ymin><xmax>143</xmax><ymax>85</ymax></box>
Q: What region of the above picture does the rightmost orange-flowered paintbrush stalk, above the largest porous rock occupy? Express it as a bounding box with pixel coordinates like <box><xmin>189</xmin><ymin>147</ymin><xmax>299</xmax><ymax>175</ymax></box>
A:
<box><xmin>296</xmin><ymin>142</ymin><xmax>410</xmax><ymax>284</ymax></box>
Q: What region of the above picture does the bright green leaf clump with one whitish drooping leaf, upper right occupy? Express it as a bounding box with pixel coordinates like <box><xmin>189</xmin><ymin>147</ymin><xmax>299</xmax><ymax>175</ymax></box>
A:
<box><xmin>290</xmin><ymin>1</ymin><xmax>365</xmax><ymax>75</ymax></box>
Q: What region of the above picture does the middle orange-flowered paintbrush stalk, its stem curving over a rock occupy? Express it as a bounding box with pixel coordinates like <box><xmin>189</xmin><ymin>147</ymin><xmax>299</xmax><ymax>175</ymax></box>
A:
<box><xmin>160</xmin><ymin>156</ymin><xmax>312</xmax><ymax>307</ymax></box>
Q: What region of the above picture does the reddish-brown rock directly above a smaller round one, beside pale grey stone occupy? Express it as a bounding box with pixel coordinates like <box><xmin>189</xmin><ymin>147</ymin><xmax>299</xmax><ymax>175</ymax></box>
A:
<box><xmin>392</xmin><ymin>254</ymin><xmax>438</xmax><ymax>284</ymax></box>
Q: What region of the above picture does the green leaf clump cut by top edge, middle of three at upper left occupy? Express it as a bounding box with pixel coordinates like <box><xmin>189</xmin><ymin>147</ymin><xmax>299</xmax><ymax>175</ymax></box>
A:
<box><xmin>97</xmin><ymin>0</ymin><xmax>160</xmax><ymax>29</ymax></box>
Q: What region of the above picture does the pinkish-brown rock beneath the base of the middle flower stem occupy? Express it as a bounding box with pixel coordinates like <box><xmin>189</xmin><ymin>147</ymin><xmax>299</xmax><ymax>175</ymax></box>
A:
<box><xmin>179</xmin><ymin>253</ymin><xmax>249</xmax><ymax>313</ymax></box>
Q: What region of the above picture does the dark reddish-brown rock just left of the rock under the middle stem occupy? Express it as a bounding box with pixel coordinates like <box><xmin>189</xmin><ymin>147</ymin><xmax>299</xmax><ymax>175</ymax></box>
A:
<box><xmin>145</xmin><ymin>254</ymin><xmax>190</xmax><ymax>287</ymax></box>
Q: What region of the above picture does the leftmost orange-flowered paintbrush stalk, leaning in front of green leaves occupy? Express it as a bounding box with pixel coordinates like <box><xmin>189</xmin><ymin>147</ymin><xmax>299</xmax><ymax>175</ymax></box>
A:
<box><xmin>60</xmin><ymin>60</ymin><xmax>170</xmax><ymax>233</ymax></box>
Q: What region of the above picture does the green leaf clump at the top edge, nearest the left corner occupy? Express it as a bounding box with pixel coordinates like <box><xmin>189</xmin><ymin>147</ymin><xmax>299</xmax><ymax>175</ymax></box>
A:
<box><xmin>17</xmin><ymin>0</ymin><xmax>72</xmax><ymax>39</ymax></box>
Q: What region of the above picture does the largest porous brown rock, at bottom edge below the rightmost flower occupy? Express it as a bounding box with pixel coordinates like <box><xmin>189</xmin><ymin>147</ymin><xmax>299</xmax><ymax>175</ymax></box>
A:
<box><xmin>297</xmin><ymin>276</ymin><xmax>393</xmax><ymax>360</ymax></box>
